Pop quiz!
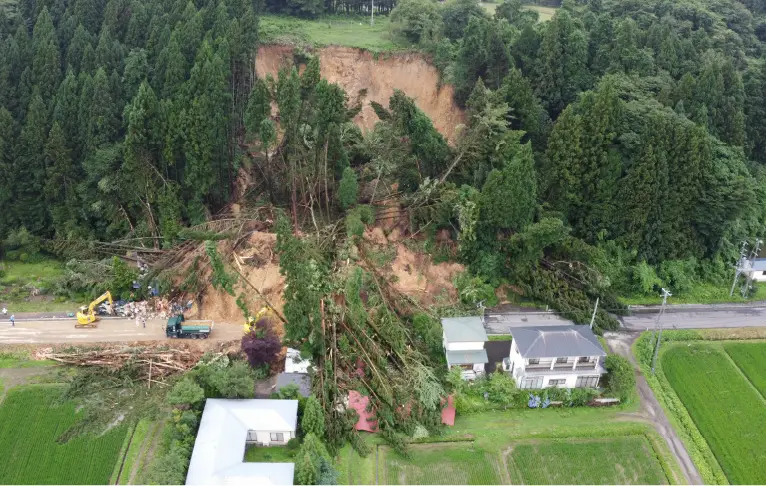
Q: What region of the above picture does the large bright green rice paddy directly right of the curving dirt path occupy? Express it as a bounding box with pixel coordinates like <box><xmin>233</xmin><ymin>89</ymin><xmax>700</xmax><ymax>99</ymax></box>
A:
<box><xmin>662</xmin><ymin>343</ymin><xmax>766</xmax><ymax>484</ymax></box>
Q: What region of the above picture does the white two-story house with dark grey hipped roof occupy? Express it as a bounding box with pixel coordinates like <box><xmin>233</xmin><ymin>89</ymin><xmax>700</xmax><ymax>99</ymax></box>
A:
<box><xmin>503</xmin><ymin>325</ymin><xmax>606</xmax><ymax>388</ymax></box>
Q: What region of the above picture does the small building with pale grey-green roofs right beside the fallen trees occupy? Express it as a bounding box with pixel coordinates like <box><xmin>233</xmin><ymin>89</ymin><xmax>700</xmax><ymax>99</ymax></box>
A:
<box><xmin>442</xmin><ymin>316</ymin><xmax>489</xmax><ymax>380</ymax></box>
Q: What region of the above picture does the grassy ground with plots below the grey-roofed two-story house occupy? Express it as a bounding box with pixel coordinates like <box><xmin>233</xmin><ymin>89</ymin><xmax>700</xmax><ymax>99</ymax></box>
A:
<box><xmin>344</xmin><ymin>408</ymin><xmax>683</xmax><ymax>484</ymax></box>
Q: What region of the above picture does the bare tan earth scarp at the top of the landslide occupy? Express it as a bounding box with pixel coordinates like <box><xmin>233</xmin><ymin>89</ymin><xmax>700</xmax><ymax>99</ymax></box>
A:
<box><xmin>255</xmin><ymin>45</ymin><xmax>465</xmax><ymax>140</ymax></box>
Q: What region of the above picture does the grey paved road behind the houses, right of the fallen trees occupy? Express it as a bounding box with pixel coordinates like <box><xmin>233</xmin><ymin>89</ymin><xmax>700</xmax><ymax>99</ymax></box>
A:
<box><xmin>484</xmin><ymin>305</ymin><xmax>766</xmax><ymax>334</ymax></box>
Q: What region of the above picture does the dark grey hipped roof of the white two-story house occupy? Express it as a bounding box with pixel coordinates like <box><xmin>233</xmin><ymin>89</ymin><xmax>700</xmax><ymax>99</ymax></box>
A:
<box><xmin>511</xmin><ymin>325</ymin><xmax>606</xmax><ymax>358</ymax></box>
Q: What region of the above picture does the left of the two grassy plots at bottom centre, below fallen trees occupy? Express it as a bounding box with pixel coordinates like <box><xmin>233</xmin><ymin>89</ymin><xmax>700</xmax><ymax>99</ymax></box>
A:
<box><xmin>380</xmin><ymin>442</ymin><xmax>502</xmax><ymax>484</ymax></box>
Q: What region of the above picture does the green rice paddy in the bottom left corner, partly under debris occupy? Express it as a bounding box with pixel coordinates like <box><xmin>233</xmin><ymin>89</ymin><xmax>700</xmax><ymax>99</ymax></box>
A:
<box><xmin>0</xmin><ymin>385</ymin><xmax>126</xmax><ymax>484</ymax></box>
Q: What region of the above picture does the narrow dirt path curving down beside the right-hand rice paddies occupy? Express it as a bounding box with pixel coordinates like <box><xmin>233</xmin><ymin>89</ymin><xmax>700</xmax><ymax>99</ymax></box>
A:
<box><xmin>604</xmin><ymin>333</ymin><xmax>703</xmax><ymax>484</ymax></box>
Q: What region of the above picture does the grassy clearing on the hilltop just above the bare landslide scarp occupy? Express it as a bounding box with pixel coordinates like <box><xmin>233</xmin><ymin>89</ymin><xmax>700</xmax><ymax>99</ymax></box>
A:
<box><xmin>259</xmin><ymin>15</ymin><xmax>410</xmax><ymax>52</ymax></box>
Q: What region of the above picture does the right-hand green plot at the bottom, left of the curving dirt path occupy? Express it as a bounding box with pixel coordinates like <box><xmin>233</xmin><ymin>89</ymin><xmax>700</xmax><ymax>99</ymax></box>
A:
<box><xmin>507</xmin><ymin>436</ymin><xmax>668</xmax><ymax>484</ymax></box>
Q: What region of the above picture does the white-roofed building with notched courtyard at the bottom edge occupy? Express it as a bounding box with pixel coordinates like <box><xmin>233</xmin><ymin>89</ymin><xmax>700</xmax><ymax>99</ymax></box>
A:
<box><xmin>186</xmin><ymin>398</ymin><xmax>298</xmax><ymax>485</ymax></box>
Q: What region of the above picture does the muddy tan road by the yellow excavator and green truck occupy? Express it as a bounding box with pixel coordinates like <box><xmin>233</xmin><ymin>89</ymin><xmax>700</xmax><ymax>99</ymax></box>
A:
<box><xmin>0</xmin><ymin>319</ymin><xmax>242</xmax><ymax>345</ymax></box>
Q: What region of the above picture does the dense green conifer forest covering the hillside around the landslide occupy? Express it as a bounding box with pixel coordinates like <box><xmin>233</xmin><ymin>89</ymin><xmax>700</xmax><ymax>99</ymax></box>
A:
<box><xmin>0</xmin><ymin>0</ymin><xmax>766</xmax><ymax>327</ymax></box>
